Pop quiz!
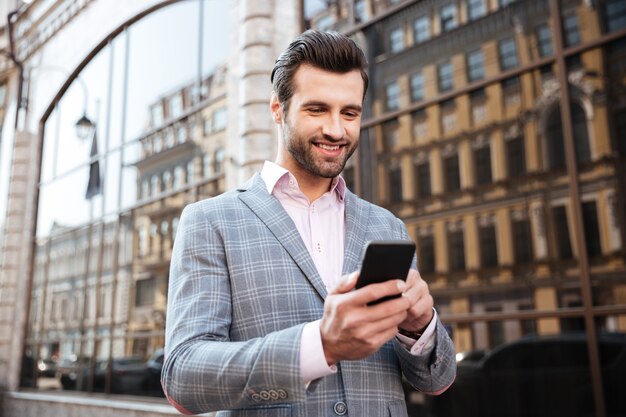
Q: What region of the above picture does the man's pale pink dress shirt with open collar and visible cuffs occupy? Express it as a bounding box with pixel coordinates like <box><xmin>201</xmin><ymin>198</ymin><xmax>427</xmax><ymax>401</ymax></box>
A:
<box><xmin>261</xmin><ymin>161</ymin><xmax>437</xmax><ymax>382</ymax></box>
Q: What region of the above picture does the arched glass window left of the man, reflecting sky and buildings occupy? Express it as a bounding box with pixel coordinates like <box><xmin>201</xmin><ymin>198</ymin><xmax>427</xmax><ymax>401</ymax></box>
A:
<box><xmin>22</xmin><ymin>0</ymin><xmax>229</xmax><ymax>396</ymax></box>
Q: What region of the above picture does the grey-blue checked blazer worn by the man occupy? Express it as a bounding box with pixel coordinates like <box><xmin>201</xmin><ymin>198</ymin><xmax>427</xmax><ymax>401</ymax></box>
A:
<box><xmin>162</xmin><ymin>175</ymin><xmax>456</xmax><ymax>417</ymax></box>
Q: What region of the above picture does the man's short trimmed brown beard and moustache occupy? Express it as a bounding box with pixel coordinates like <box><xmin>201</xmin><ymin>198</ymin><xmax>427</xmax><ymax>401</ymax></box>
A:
<box><xmin>283</xmin><ymin>118</ymin><xmax>358</xmax><ymax>178</ymax></box>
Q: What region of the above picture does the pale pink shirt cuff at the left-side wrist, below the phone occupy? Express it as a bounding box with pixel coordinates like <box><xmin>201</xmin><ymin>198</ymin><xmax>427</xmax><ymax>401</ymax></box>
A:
<box><xmin>300</xmin><ymin>320</ymin><xmax>337</xmax><ymax>386</ymax></box>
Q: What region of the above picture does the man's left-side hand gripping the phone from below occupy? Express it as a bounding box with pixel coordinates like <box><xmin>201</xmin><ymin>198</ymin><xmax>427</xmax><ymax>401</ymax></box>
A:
<box><xmin>320</xmin><ymin>271</ymin><xmax>412</xmax><ymax>365</ymax></box>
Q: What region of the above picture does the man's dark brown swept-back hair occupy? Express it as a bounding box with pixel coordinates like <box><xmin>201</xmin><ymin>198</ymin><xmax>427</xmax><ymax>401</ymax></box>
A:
<box><xmin>271</xmin><ymin>30</ymin><xmax>369</xmax><ymax>110</ymax></box>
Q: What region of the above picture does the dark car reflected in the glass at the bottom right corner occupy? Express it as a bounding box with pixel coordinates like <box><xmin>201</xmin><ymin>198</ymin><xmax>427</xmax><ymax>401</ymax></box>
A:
<box><xmin>428</xmin><ymin>333</ymin><xmax>626</xmax><ymax>417</ymax></box>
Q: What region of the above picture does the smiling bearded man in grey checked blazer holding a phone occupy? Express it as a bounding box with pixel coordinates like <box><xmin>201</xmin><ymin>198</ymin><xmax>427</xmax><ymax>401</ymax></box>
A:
<box><xmin>162</xmin><ymin>31</ymin><xmax>456</xmax><ymax>417</ymax></box>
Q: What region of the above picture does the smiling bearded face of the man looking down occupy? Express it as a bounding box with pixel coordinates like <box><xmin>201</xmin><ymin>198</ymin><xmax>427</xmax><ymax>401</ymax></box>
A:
<box><xmin>271</xmin><ymin>65</ymin><xmax>363</xmax><ymax>178</ymax></box>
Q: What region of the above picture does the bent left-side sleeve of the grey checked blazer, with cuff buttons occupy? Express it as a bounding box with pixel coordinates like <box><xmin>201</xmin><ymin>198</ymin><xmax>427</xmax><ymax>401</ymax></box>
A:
<box><xmin>161</xmin><ymin>203</ymin><xmax>305</xmax><ymax>414</ymax></box>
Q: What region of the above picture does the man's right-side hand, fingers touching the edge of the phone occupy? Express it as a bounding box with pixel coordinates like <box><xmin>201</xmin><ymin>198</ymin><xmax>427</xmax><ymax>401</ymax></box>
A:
<box><xmin>399</xmin><ymin>269</ymin><xmax>434</xmax><ymax>333</ymax></box>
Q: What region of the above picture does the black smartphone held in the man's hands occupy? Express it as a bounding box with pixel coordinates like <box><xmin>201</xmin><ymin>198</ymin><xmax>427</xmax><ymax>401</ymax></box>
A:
<box><xmin>355</xmin><ymin>240</ymin><xmax>415</xmax><ymax>305</ymax></box>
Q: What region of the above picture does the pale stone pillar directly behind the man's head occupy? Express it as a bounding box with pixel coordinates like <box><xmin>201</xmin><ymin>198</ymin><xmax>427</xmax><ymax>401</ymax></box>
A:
<box><xmin>226</xmin><ymin>0</ymin><xmax>300</xmax><ymax>189</ymax></box>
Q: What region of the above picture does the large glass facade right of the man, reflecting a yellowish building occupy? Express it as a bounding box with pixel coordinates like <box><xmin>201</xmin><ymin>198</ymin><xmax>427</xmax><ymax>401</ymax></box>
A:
<box><xmin>305</xmin><ymin>0</ymin><xmax>626</xmax><ymax>417</ymax></box>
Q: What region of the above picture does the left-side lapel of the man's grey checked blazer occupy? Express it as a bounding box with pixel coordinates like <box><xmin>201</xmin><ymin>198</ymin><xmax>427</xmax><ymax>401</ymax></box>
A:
<box><xmin>239</xmin><ymin>174</ymin><xmax>328</xmax><ymax>299</ymax></box>
